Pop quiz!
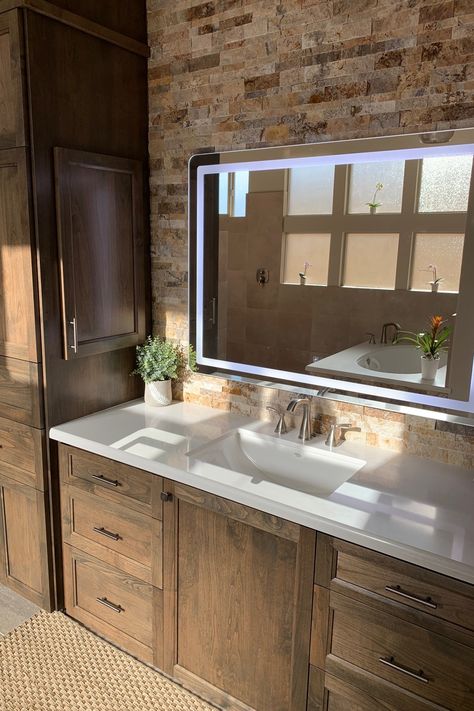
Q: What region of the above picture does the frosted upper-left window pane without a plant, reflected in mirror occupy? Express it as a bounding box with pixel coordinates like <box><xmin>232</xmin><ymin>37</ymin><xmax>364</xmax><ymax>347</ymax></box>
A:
<box><xmin>288</xmin><ymin>165</ymin><xmax>334</xmax><ymax>215</ymax></box>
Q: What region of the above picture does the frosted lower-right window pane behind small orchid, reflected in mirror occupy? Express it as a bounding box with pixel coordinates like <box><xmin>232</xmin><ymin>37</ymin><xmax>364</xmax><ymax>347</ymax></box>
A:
<box><xmin>410</xmin><ymin>234</ymin><xmax>464</xmax><ymax>292</ymax></box>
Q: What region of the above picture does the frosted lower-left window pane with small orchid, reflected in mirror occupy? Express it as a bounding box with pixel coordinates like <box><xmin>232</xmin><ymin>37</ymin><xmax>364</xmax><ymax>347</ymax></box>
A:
<box><xmin>283</xmin><ymin>234</ymin><xmax>331</xmax><ymax>286</ymax></box>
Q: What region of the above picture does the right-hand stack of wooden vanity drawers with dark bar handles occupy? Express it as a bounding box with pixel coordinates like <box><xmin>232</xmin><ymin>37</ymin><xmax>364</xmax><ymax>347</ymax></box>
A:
<box><xmin>308</xmin><ymin>534</ymin><xmax>474</xmax><ymax>711</ymax></box>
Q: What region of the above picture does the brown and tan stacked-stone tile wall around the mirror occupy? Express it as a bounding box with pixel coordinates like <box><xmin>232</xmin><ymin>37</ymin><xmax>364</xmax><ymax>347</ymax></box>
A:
<box><xmin>148</xmin><ymin>0</ymin><xmax>474</xmax><ymax>467</ymax></box>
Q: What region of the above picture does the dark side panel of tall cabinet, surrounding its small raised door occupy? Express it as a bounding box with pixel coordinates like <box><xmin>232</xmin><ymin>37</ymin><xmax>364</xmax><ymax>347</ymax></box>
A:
<box><xmin>25</xmin><ymin>11</ymin><xmax>149</xmax><ymax>426</ymax></box>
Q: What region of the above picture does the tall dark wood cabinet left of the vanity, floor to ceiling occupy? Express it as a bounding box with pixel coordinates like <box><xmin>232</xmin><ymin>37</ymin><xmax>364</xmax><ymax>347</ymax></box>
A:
<box><xmin>0</xmin><ymin>0</ymin><xmax>150</xmax><ymax>608</ymax></box>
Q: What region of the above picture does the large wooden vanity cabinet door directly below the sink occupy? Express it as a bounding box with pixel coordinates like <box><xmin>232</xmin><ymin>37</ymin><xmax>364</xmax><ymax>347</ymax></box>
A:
<box><xmin>163</xmin><ymin>484</ymin><xmax>315</xmax><ymax>711</ymax></box>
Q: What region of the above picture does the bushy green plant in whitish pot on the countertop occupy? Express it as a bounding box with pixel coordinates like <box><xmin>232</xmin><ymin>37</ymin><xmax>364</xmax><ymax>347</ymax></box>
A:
<box><xmin>132</xmin><ymin>336</ymin><xmax>196</xmax><ymax>407</ymax></box>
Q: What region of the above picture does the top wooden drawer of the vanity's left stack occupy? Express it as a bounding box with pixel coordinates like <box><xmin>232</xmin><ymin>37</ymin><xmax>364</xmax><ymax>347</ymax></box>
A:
<box><xmin>59</xmin><ymin>445</ymin><xmax>163</xmax><ymax>520</ymax></box>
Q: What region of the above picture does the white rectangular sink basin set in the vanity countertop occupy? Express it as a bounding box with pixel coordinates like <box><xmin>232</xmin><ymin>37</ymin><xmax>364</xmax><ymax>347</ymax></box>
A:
<box><xmin>187</xmin><ymin>429</ymin><xmax>366</xmax><ymax>496</ymax></box>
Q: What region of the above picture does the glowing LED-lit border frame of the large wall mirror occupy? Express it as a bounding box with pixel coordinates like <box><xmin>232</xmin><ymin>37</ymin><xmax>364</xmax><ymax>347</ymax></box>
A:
<box><xmin>188</xmin><ymin>128</ymin><xmax>474</xmax><ymax>413</ymax></box>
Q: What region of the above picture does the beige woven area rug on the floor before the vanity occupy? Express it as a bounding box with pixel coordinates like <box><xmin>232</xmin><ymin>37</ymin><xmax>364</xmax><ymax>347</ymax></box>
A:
<box><xmin>0</xmin><ymin>612</ymin><xmax>215</xmax><ymax>711</ymax></box>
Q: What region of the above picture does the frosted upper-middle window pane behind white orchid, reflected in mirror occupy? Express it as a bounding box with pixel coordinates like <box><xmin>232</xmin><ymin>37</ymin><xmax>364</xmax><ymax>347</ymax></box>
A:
<box><xmin>348</xmin><ymin>160</ymin><xmax>405</xmax><ymax>214</ymax></box>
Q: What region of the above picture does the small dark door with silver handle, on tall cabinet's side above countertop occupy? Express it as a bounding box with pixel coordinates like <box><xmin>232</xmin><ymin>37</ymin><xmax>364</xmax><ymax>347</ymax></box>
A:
<box><xmin>54</xmin><ymin>148</ymin><xmax>145</xmax><ymax>359</ymax></box>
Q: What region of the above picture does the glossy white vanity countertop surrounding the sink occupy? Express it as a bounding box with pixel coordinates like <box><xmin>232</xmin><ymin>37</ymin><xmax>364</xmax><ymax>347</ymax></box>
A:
<box><xmin>50</xmin><ymin>400</ymin><xmax>474</xmax><ymax>583</ymax></box>
